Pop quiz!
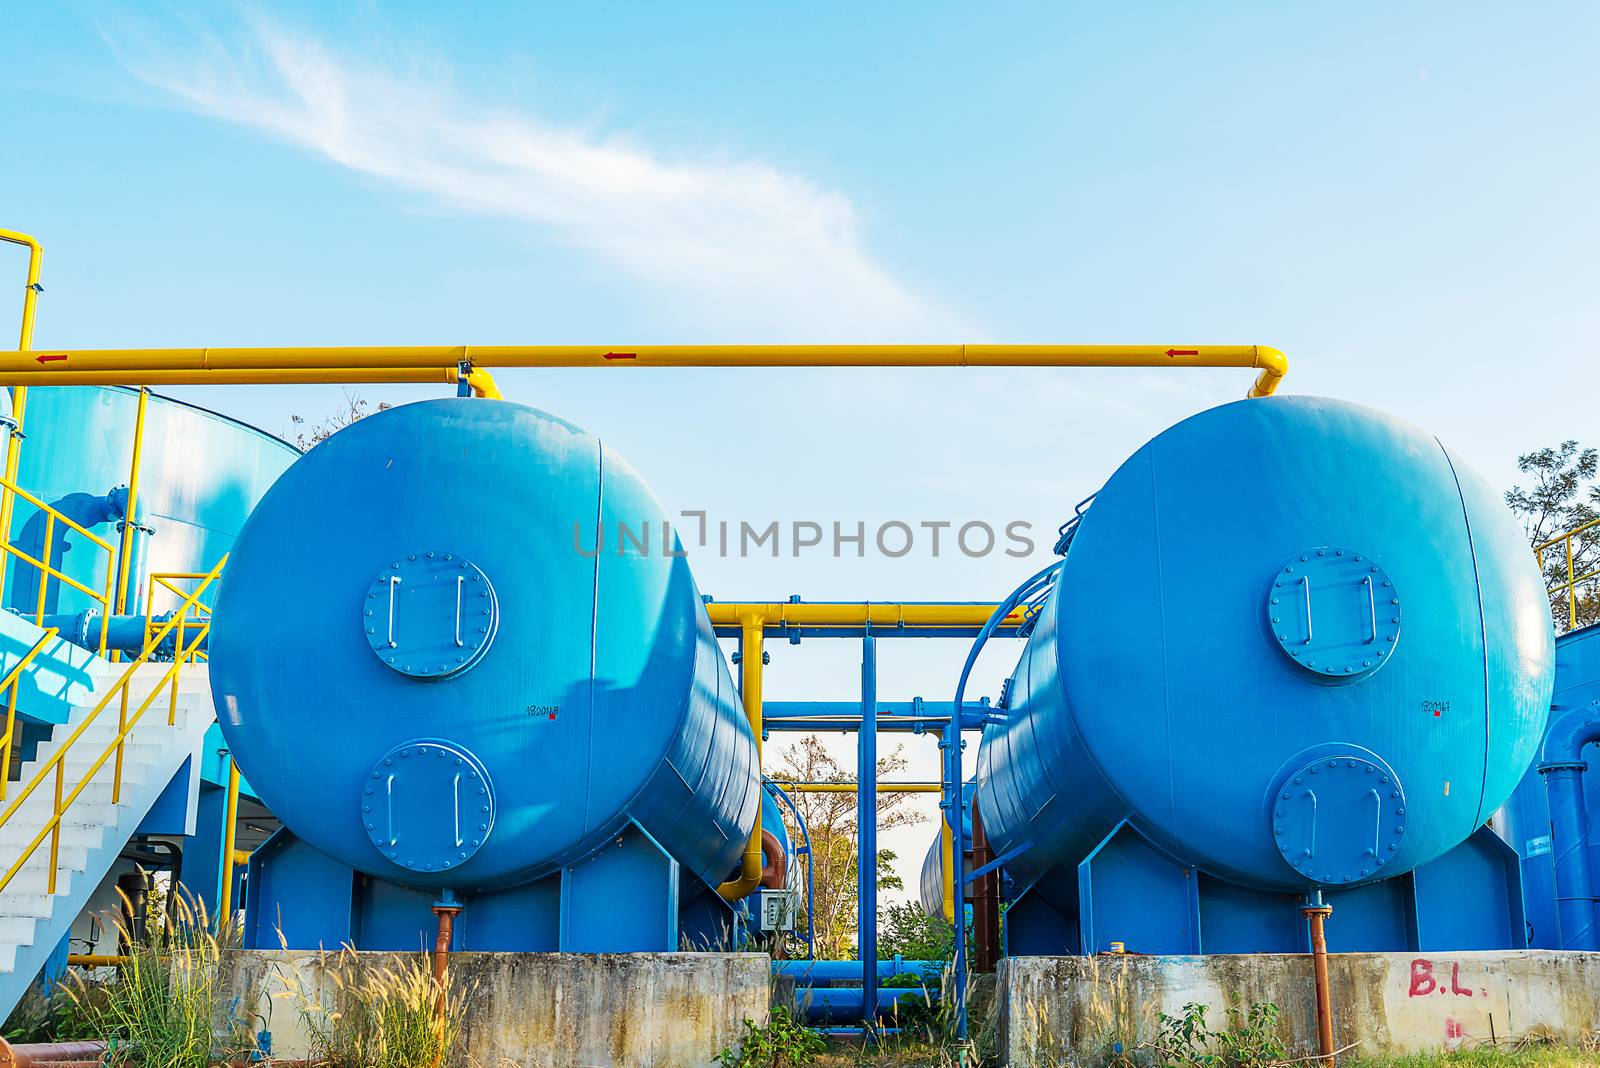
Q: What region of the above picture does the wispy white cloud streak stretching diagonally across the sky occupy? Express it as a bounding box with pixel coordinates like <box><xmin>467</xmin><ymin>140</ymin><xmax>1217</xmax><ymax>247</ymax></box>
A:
<box><xmin>116</xmin><ymin>16</ymin><xmax>960</xmax><ymax>339</ymax></box>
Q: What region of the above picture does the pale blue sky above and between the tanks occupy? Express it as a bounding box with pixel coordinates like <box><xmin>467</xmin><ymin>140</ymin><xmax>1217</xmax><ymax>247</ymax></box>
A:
<box><xmin>0</xmin><ymin>2</ymin><xmax>1600</xmax><ymax>895</ymax></box>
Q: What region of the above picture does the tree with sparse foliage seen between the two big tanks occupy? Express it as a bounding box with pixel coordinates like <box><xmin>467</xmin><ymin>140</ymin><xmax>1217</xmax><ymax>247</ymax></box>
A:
<box><xmin>773</xmin><ymin>737</ymin><xmax>923</xmax><ymax>961</ymax></box>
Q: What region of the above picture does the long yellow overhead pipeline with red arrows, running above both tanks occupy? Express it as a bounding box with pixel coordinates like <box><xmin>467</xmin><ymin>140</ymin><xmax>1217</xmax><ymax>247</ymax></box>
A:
<box><xmin>0</xmin><ymin>344</ymin><xmax>1288</xmax><ymax>397</ymax></box>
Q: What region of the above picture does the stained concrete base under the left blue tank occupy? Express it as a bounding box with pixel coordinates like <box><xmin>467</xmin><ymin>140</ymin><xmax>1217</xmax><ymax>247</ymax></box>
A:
<box><xmin>234</xmin><ymin>950</ymin><xmax>771</xmax><ymax>1068</ymax></box>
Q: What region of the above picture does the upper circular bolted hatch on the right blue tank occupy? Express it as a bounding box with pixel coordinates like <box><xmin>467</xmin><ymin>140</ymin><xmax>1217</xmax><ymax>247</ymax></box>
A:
<box><xmin>1264</xmin><ymin>545</ymin><xmax>1400</xmax><ymax>679</ymax></box>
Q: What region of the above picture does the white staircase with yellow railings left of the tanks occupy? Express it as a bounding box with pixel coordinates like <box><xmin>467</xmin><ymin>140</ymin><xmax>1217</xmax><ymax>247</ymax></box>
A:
<box><xmin>0</xmin><ymin>659</ymin><xmax>216</xmax><ymax>1015</ymax></box>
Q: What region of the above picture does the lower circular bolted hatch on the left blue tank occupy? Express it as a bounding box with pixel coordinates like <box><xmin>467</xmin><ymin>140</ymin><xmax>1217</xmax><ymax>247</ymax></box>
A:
<box><xmin>362</xmin><ymin>739</ymin><xmax>494</xmax><ymax>871</ymax></box>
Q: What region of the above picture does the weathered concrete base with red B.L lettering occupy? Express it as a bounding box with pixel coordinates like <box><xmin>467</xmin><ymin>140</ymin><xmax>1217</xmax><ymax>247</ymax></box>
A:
<box><xmin>997</xmin><ymin>950</ymin><xmax>1600</xmax><ymax>1068</ymax></box>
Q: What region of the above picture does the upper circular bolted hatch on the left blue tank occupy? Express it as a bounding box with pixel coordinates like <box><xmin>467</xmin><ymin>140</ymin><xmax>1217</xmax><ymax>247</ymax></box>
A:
<box><xmin>362</xmin><ymin>550</ymin><xmax>499</xmax><ymax>679</ymax></box>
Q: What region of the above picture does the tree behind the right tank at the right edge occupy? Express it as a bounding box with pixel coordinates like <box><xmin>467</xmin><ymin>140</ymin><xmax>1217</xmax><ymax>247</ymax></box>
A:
<box><xmin>1506</xmin><ymin>441</ymin><xmax>1600</xmax><ymax>630</ymax></box>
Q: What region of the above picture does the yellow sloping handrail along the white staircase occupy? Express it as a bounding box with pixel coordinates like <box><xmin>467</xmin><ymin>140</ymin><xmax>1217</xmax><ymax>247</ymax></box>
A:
<box><xmin>0</xmin><ymin>555</ymin><xmax>227</xmax><ymax>894</ymax></box>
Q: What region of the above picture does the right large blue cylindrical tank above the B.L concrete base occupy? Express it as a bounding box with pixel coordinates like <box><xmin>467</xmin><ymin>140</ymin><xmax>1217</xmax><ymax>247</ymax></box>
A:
<box><xmin>978</xmin><ymin>397</ymin><xmax>1552</xmax><ymax>897</ymax></box>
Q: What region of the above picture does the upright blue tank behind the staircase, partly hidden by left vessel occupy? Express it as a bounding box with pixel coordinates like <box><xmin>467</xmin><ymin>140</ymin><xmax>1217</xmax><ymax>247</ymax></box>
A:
<box><xmin>5</xmin><ymin>387</ymin><xmax>299</xmax><ymax>617</ymax></box>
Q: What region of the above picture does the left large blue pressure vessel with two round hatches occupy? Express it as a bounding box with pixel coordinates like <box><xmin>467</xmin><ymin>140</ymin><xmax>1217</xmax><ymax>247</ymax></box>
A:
<box><xmin>211</xmin><ymin>400</ymin><xmax>760</xmax><ymax>891</ymax></box>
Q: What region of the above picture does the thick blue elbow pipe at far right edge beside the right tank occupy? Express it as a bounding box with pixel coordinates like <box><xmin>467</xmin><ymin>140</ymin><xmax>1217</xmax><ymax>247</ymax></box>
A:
<box><xmin>1539</xmin><ymin>703</ymin><xmax>1600</xmax><ymax>951</ymax></box>
